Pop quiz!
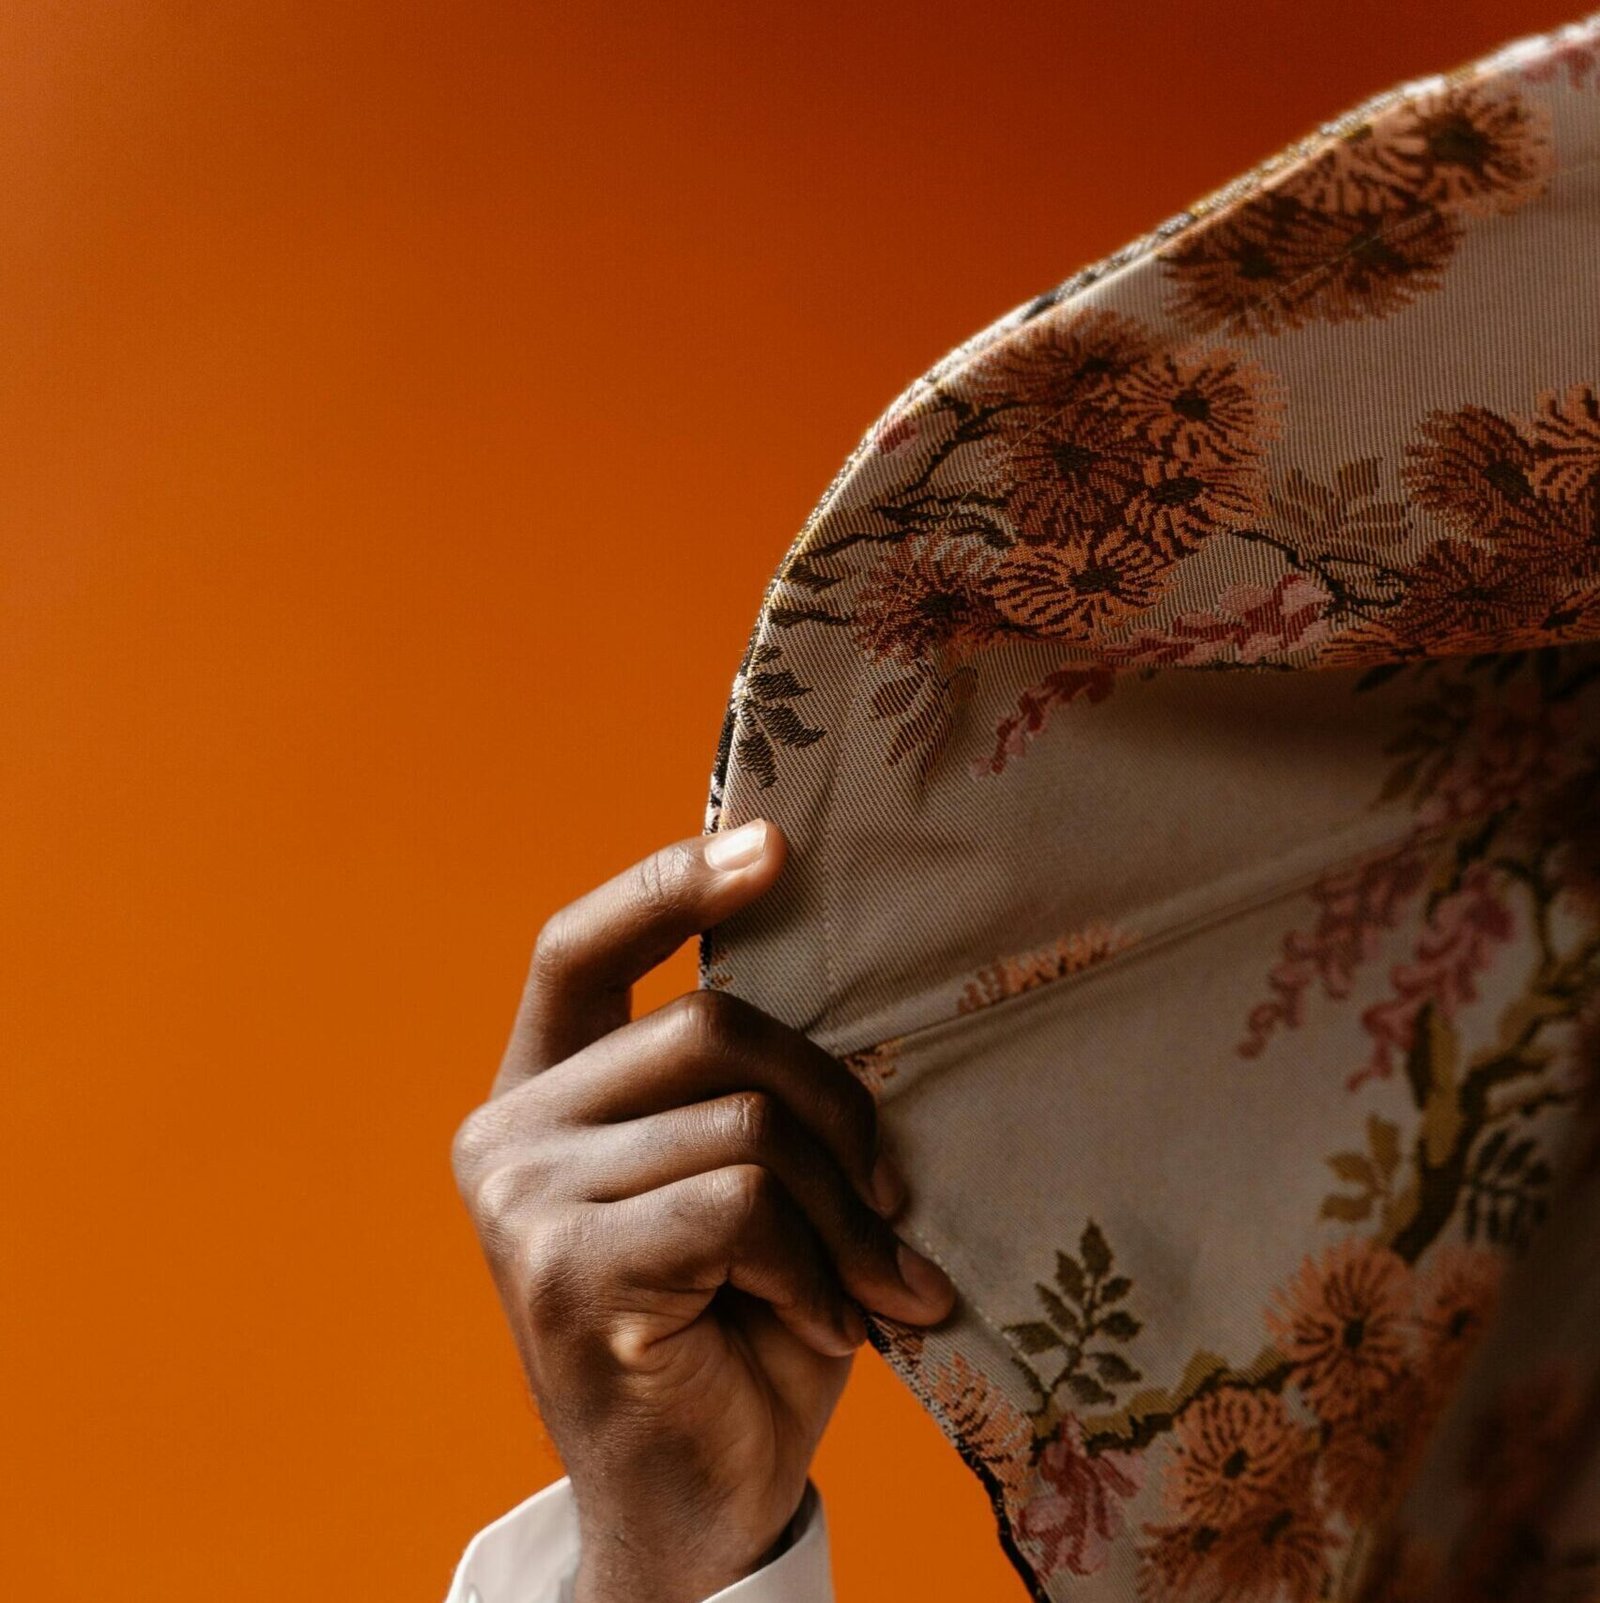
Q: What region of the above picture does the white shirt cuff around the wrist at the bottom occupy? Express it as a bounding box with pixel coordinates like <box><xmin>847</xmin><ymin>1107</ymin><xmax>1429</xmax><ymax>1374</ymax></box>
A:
<box><xmin>444</xmin><ymin>1480</ymin><xmax>834</xmax><ymax>1603</ymax></box>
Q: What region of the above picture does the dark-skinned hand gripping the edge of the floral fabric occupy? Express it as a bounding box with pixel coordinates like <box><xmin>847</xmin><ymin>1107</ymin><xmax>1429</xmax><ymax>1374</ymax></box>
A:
<box><xmin>454</xmin><ymin>821</ymin><xmax>954</xmax><ymax>1603</ymax></box>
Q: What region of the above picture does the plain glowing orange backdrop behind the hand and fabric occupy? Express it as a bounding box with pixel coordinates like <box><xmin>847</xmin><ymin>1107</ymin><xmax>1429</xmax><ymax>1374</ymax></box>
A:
<box><xmin>0</xmin><ymin>0</ymin><xmax>1565</xmax><ymax>1603</ymax></box>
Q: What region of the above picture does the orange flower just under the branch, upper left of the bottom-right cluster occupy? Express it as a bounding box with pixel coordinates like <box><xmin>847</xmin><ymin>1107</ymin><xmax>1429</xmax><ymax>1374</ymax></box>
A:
<box><xmin>1166</xmin><ymin>1390</ymin><xmax>1313</xmax><ymax>1528</ymax></box>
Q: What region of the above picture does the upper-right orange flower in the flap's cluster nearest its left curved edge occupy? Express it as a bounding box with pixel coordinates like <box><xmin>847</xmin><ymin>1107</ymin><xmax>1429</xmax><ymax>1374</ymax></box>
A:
<box><xmin>1117</xmin><ymin>351</ymin><xmax>1278</xmax><ymax>462</ymax></box>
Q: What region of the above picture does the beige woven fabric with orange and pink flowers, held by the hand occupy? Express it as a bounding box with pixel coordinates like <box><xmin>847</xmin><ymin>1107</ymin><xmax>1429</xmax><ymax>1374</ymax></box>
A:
<box><xmin>702</xmin><ymin>18</ymin><xmax>1600</xmax><ymax>1603</ymax></box>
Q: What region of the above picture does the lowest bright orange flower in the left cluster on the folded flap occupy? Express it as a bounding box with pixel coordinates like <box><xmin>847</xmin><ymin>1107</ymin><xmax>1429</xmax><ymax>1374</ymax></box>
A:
<box><xmin>984</xmin><ymin>531</ymin><xmax>1172</xmax><ymax>641</ymax></box>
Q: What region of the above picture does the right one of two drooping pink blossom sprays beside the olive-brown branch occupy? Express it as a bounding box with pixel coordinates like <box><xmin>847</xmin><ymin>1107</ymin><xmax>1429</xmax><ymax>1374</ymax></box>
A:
<box><xmin>1350</xmin><ymin>862</ymin><xmax>1515</xmax><ymax>1090</ymax></box>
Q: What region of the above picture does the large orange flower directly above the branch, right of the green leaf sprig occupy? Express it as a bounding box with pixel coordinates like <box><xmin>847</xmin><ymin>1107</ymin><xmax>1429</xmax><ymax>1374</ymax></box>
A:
<box><xmin>1267</xmin><ymin>1241</ymin><xmax>1411</xmax><ymax>1420</ymax></box>
